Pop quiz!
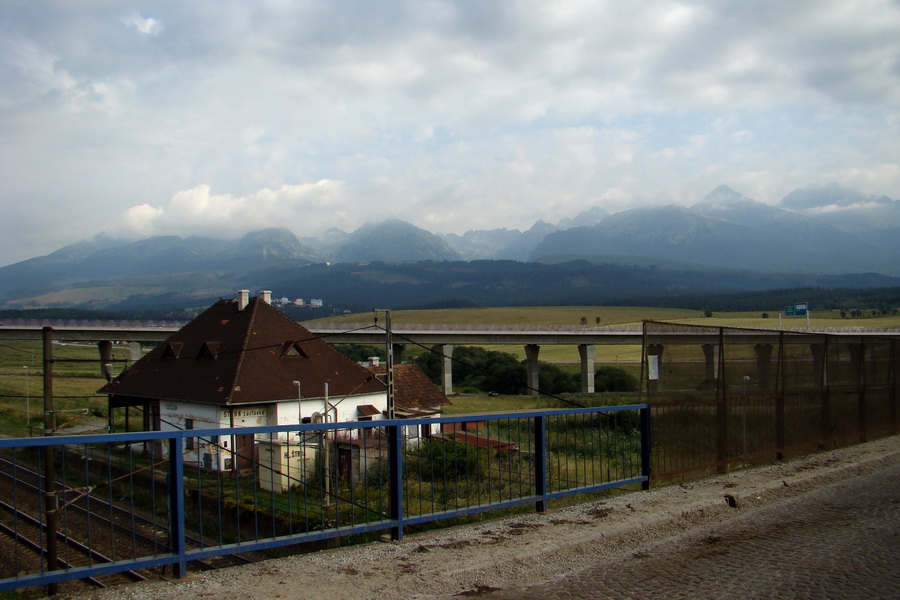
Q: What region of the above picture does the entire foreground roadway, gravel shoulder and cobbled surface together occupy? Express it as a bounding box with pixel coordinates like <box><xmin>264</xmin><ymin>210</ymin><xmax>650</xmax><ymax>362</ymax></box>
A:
<box><xmin>60</xmin><ymin>436</ymin><xmax>900</xmax><ymax>600</ymax></box>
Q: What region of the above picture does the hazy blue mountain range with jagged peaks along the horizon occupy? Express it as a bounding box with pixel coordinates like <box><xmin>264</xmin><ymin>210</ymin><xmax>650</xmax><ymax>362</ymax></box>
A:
<box><xmin>0</xmin><ymin>184</ymin><xmax>900</xmax><ymax>308</ymax></box>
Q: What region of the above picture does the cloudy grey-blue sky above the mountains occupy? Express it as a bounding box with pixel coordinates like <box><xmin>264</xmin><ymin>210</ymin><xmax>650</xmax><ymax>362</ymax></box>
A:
<box><xmin>0</xmin><ymin>0</ymin><xmax>900</xmax><ymax>264</ymax></box>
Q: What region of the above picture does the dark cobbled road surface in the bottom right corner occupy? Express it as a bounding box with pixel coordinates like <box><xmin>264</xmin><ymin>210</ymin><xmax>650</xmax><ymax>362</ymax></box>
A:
<box><xmin>479</xmin><ymin>464</ymin><xmax>900</xmax><ymax>600</ymax></box>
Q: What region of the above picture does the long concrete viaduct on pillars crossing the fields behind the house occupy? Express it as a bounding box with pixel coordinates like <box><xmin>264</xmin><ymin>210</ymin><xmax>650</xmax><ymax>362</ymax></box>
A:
<box><xmin>0</xmin><ymin>321</ymin><xmax>900</xmax><ymax>395</ymax></box>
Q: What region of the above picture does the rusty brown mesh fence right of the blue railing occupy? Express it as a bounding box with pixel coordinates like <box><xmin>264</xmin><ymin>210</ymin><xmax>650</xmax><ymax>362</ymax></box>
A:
<box><xmin>642</xmin><ymin>321</ymin><xmax>900</xmax><ymax>481</ymax></box>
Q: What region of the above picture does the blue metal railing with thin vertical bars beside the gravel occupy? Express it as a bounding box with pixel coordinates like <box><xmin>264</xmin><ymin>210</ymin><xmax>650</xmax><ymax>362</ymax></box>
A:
<box><xmin>0</xmin><ymin>404</ymin><xmax>650</xmax><ymax>591</ymax></box>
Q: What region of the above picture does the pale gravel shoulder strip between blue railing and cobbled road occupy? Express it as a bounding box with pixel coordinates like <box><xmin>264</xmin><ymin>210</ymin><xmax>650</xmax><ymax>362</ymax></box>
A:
<box><xmin>59</xmin><ymin>436</ymin><xmax>900</xmax><ymax>600</ymax></box>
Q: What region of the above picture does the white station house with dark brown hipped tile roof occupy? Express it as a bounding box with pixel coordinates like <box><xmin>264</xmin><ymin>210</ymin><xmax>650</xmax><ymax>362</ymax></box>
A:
<box><xmin>100</xmin><ymin>290</ymin><xmax>387</xmax><ymax>470</ymax></box>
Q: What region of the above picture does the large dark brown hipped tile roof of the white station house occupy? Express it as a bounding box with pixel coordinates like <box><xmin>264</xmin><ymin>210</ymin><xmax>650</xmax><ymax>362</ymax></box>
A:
<box><xmin>100</xmin><ymin>298</ymin><xmax>385</xmax><ymax>404</ymax></box>
